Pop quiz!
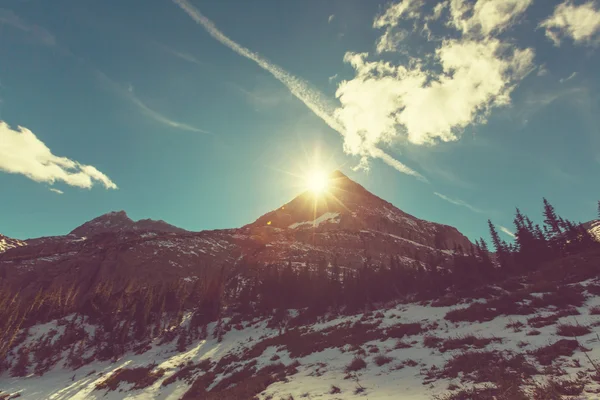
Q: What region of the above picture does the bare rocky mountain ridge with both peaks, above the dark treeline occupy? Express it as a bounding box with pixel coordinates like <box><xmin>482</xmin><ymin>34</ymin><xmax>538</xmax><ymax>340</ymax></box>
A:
<box><xmin>0</xmin><ymin>171</ymin><xmax>471</xmax><ymax>304</ymax></box>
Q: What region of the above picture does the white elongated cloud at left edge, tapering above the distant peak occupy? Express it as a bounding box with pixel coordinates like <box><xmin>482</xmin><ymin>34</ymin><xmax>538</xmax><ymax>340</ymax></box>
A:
<box><xmin>0</xmin><ymin>121</ymin><xmax>117</xmax><ymax>189</ymax></box>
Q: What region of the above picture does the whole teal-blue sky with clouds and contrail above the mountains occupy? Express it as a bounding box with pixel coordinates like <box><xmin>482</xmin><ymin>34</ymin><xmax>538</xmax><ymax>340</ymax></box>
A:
<box><xmin>0</xmin><ymin>0</ymin><xmax>600</xmax><ymax>240</ymax></box>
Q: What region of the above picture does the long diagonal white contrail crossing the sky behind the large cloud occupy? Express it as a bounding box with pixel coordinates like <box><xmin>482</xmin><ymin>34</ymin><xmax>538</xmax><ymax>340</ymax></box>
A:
<box><xmin>173</xmin><ymin>0</ymin><xmax>427</xmax><ymax>182</ymax></box>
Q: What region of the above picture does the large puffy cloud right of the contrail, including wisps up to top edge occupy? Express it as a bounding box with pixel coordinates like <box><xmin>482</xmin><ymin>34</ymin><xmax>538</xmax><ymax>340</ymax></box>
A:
<box><xmin>335</xmin><ymin>0</ymin><xmax>534</xmax><ymax>148</ymax></box>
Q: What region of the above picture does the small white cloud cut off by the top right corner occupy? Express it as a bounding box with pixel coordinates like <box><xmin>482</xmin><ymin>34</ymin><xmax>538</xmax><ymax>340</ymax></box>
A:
<box><xmin>540</xmin><ymin>0</ymin><xmax>600</xmax><ymax>46</ymax></box>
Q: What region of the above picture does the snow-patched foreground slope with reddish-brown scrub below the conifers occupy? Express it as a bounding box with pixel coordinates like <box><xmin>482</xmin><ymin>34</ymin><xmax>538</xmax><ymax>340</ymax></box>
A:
<box><xmin>0</xmin><ymin>280</ymin><xmax>600</xmax><ymax>400</ymax></box>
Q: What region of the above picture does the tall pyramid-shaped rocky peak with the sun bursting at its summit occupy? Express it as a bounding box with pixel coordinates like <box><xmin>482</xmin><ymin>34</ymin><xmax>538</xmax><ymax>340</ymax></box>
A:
<box><xmin>241</xmin><ymin>171</ymin><xmax>472</xmax><ymax>268</ymax></box>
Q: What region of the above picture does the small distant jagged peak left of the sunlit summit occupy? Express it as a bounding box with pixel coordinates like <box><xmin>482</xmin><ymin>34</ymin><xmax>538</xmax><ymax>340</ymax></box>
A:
<box><xmin>70</xmin><ymin>210</ymin><xmax>187</xmax><ymax>237</ymax></box>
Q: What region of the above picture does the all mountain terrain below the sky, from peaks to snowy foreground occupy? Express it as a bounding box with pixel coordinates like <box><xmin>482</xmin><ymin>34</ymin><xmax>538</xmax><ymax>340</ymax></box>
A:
<box><xmin>0</xmin><ymin>172</ymin><xmax>600</xmax><ymax>400</ymax></box>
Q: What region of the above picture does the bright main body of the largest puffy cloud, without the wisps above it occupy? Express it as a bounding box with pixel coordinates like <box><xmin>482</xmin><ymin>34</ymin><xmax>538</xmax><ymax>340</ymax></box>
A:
<box><xmin>336</xmin><ymin>38</ymin><xmax>533</xmax><ymax>147</ymax></box>
